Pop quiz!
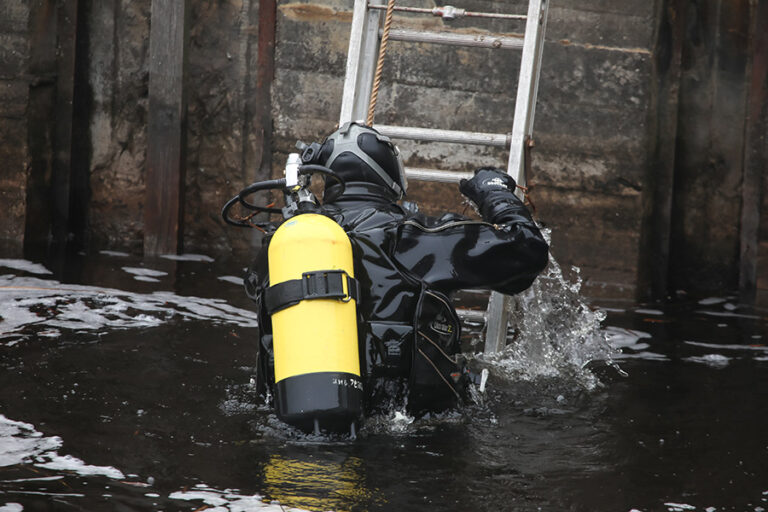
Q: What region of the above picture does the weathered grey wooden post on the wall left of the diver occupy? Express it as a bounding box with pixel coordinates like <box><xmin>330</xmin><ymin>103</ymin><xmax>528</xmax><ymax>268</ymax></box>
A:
<box><xmin>144</xmin><ymin>0</ymin><xmax>189</xmax><ymax>255</ymax></box>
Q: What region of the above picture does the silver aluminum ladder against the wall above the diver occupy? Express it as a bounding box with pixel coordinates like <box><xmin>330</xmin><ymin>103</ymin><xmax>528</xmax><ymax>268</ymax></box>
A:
<box><xmin>339</xmin><ymin>0</ymin><xmax>549</xmax><ymax>353</ymax></box>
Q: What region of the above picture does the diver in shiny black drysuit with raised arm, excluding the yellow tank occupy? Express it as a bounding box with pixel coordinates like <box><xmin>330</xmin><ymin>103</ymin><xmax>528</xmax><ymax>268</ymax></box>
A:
<box><xmin>237</xmin><ymin>123</ymin><xmax>548</xmax><ymax>429</ymax></box>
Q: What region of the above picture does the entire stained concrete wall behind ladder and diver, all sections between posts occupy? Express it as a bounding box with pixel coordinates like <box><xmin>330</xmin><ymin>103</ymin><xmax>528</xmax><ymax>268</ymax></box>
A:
<box><xmin>0</xmin><ymin>0</ymin><xmax>768</xmax><ymax>297</ymax></box>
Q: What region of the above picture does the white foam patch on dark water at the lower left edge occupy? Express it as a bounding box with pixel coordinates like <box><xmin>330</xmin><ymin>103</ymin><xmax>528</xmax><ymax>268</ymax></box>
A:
<box><xmin>0</xmin><ymin>414</ymin><xmax>125</xmax><ymax>480</ymax></box>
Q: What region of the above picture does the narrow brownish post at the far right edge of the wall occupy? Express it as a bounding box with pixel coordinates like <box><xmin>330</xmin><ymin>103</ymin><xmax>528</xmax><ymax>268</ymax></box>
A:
<box><xmin>739</xmin><ymin>0</ymin><xmax>768</xmax><ymax>302</ymax></box>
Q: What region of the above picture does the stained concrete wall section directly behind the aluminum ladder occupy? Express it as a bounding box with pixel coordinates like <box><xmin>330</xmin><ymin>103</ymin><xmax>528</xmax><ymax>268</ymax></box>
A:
<box><xmin>274</xmin><ymin>0</ymin><xmax>655</xmax><ymax>296</ymax></box>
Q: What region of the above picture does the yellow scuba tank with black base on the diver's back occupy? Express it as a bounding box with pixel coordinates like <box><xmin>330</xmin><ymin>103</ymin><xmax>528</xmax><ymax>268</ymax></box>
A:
<box><xmin>265</xmin><ymin>213</ymin><xmax>363</xmax><ymax>433</ymax></box>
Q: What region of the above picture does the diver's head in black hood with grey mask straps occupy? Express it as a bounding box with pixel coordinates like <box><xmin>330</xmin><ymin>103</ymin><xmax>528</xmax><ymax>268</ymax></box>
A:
<box><xmin>302</xmin><ymin>123</ymin><xmax>407</xmax><ymax>200</ymax></box>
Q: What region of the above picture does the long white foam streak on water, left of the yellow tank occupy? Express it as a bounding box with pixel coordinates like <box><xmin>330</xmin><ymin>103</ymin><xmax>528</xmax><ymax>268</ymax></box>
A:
<box><xmin>0</xmin><ymin>275</ymin><xmax>258</xmax><ymax>339</ymax></box>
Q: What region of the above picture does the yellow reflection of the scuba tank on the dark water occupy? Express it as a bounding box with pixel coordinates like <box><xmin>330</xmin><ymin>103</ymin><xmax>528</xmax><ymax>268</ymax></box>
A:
<box><xmin>263</xmin><ymin>452</ymin><xmax>375</xmax><ymax>511</ymax></box>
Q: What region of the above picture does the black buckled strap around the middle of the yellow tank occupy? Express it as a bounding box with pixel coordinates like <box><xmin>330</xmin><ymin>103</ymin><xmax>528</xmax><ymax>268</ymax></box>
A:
<box><xmin>264</xmin><ymin>270</ymin><xmax>360</xmax><ymax>315</ymax></box>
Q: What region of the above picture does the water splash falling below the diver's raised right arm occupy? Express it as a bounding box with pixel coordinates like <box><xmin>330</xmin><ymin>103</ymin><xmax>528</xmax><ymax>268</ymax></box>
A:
<box><xmin>481</xmin><ymin>230</ymin><xmax>624</xmax><ymax>390</ymax></box>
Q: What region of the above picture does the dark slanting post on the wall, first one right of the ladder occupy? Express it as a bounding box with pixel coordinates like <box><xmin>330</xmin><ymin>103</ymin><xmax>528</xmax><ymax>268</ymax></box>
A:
<box><xmin>638</xmin><ymin>0</ymin><xmax>688</xmax><ymax>300</ymax></box>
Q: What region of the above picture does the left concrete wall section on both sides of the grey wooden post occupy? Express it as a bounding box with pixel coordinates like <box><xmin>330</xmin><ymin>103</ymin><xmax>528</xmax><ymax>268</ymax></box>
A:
<box><xmin>81</xmin><ymin>0</ymin><xmax>260</xmax><ymax>252</ymax></box>
